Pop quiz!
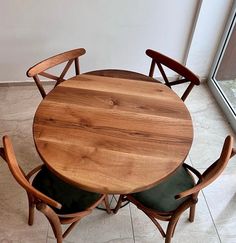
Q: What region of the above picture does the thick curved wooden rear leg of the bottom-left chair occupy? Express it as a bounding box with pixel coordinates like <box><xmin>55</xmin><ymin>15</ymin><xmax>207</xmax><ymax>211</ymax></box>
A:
<box><xmin>36</xmin><ymin>203</ymin><xmax>63</xmax><ymax>243</ymax></box>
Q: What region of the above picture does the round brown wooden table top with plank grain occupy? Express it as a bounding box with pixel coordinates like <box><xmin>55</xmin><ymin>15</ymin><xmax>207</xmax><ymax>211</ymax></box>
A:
<box><xmin>33</xmin><ymin>74</ymin><xmax>193</xmax><ymax>194</ymax></box>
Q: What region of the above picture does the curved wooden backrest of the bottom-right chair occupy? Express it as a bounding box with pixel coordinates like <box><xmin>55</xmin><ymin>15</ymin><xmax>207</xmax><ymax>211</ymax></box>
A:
<box><xmin>175</xmin><ymin>136</ymin><xmax>236</xmax><ymax>199</ymax></box>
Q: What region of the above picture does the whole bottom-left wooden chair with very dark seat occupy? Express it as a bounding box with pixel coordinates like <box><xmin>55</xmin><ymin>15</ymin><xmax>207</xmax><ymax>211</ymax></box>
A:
<box><xmin>0</xmin><ymin>136</ymin><xmax>111</xmax><ymax>243</ymax></box>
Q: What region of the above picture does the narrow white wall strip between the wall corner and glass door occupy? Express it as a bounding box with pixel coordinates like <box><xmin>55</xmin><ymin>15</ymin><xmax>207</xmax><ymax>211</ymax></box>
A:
<box><xmin>187</xmin><ymin>0</ymin><xmax>233</xmax><ymax>78</ymax></box>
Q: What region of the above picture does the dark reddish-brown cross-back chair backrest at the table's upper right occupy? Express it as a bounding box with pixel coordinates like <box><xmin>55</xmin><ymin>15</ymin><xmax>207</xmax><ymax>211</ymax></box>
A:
<box><xmin>146</xmin><ymin>49</ymin><xmax>200</xmax><ymax>101</ymax></box>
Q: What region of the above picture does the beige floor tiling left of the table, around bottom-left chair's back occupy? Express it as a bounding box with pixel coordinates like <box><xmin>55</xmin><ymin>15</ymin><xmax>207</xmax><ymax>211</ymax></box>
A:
<box><xmin>0</xmin><ymin>86</ymin><xmax>48</xmax><ymax>243</ymax></box>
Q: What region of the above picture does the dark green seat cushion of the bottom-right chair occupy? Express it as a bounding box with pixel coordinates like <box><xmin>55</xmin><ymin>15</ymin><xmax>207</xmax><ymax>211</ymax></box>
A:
<box><xmin>131</xmin><ymin>166</ymin><xmax>194</xmax><ymax>212</ymax></box>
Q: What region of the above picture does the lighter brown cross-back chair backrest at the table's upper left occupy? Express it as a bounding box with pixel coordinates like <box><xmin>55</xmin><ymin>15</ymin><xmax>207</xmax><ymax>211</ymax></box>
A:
<box><xmin>26</xmin><ymin>48</ymin><xmax>86</xmax><ymax>98</ymax></box>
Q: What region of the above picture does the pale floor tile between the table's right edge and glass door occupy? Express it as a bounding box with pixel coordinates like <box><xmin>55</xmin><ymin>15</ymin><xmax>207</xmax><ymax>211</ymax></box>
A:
<box><xmin>186</xmin><ymin>81</ymin><xmax>236</xmax><ymax>169</ymax></box>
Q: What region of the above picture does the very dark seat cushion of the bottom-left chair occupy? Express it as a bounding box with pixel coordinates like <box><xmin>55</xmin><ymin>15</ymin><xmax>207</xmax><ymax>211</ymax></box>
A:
<box><xmin>32</xmin><ymin>166</ymin><xmax>101</xmax><ymax>214</ymax></box>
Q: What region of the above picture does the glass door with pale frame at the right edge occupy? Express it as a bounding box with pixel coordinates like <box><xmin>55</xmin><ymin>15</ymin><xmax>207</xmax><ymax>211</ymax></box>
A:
<box><xmin>208</xmin><ymin>2</ymin><xmax>236</xmax><ymax>132</ymax></box>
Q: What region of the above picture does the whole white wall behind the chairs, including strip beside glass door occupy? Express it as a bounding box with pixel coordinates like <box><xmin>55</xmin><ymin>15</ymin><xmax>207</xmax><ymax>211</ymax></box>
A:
<box><xmin>0</xmin><ymin>0</ymin><xmax>232</xmax><ymax>81</ymax></box>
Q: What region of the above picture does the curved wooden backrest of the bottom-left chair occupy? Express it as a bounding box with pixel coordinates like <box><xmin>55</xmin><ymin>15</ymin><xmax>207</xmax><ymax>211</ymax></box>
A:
<box><xmin>0</xmin><ymin>136</ymin><xmax>62</xmax><ymax>209</ymax></box>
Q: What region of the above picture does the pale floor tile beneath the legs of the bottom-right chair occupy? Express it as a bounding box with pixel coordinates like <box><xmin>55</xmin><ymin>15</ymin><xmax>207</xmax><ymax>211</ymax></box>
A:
<box><xmin>131</xmin><ymin>193</ymin><xmax>220</xmax><ymax>243</ymax></box>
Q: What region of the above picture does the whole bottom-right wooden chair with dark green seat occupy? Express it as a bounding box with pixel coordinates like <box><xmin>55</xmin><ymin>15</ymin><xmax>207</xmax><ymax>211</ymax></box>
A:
<box><xmin>114</xmin><ymin>136</ymin><xmax>236</xmax><ymax>243</ymax></box>
